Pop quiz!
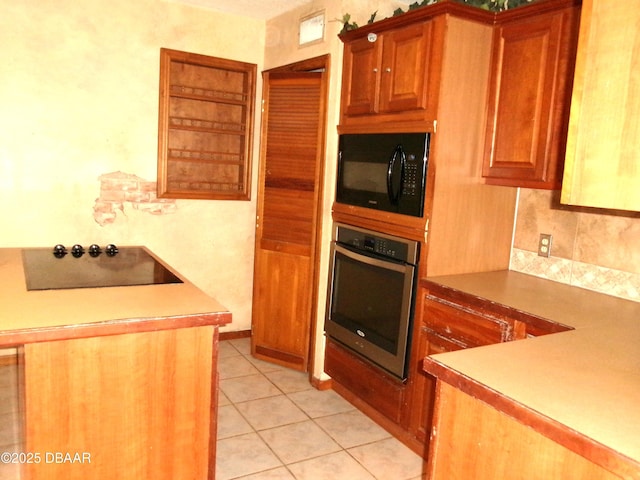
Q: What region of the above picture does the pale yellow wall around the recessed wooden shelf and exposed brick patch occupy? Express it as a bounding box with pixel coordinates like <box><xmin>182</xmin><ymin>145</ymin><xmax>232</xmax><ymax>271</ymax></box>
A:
<box><xmin>0</xmin><ymin>0</ymin><xmax>265</xmax><ymax>330</ymax></box>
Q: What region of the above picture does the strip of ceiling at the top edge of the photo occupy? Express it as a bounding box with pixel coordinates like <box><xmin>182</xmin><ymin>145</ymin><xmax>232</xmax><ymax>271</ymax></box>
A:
<box><xmin>173</xmin><ymin>0</ymin><xmax>313</xmax><ymax>20</ymax></box>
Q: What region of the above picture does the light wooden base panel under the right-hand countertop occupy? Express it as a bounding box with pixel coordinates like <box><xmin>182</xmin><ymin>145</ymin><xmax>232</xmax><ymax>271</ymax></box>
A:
<box><xmin>427</xmin><ymin>381</ymin><xmax>620</xmax><ymax>480</ymax></box>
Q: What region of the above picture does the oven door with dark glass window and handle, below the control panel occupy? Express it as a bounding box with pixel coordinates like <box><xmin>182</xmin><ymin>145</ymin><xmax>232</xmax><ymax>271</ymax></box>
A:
<box><xmin>325</xmin><ymin>242</ymin><xmax>415</xmax><ymax>379</ymax></box>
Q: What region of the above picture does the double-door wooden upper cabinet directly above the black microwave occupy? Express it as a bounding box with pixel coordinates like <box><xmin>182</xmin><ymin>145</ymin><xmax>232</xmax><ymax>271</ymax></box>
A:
<box><xmin>340</xmin><ymin>0</ymin><xmax>494</xmax><ymax>133</ymax></box>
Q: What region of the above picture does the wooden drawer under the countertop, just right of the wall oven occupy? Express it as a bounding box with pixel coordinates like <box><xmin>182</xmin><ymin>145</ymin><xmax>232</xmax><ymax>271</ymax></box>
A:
<box><xmin>423</xmin><ymin>295</ymin><xmax>510</xmax><ymax>347</ymax></box>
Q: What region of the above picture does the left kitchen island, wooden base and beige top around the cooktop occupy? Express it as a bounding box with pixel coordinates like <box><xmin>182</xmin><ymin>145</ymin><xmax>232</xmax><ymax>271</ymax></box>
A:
<box><xmin>0</xmin><ymin>249</ymin><xmax>231</xmax><ymax>480</ymax></box>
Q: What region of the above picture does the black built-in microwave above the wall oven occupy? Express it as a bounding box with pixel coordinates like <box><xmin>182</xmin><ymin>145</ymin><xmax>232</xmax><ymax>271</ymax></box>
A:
<box><xmin>336</xmin><ymin>129</ymin><xmax>430</xmax><ymax>217</ymax></box>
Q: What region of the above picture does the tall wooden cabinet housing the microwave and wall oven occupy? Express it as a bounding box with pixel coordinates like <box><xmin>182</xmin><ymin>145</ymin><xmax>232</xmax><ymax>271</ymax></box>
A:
<box><xmin>325</xmin><ymin>0</ymin><xmax>516</xmax><ymax>454</ymax></box>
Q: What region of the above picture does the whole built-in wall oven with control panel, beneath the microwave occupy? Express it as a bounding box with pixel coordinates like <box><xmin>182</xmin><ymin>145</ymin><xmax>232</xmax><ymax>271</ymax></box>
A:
<box><xmin>325</xmin><ymin>224</ymin><xmax>419</xmax><ymax>380</ymax></box>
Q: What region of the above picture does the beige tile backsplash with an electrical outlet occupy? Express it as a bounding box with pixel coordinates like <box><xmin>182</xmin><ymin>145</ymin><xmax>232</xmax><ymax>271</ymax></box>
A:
<box><xmin>511</xmin><ymin>189</ymin><xmax>640</xmax><ymax>302</ymax></box>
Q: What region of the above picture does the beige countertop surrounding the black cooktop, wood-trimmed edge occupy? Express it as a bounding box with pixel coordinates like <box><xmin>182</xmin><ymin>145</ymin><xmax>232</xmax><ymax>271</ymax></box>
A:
<box><xmin>0</xmin><ymin>248</ymin><xmax>231</xmax><ymax>348</ymax></box>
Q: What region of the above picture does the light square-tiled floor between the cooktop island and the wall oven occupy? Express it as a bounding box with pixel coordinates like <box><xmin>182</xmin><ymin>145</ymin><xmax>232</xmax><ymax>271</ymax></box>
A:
<box><xmin>216</xmin><ymin>339</ymin><xmax>423</xmax><ymax>480</ymax></box>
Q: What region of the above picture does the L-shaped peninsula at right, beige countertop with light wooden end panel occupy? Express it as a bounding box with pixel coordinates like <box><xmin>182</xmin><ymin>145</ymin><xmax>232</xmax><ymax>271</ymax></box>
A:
<box><xmin>424</xmin><ymin>271</ymin><xmax>640</xmax><ymax>480</ymax></box>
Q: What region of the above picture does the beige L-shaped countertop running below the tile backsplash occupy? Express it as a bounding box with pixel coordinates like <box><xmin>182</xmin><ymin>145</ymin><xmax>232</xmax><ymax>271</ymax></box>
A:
<box><xmin>425</xmin><ymin>271</ymin><xmax>640</xmax><ymax>478</ymax></box>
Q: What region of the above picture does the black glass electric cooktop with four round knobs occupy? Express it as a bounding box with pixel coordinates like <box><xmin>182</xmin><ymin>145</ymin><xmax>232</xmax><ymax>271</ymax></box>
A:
<box><xmin>22</xmin><ymin>244</ymin><xmax>182</xmax><ymax>290</ymax></box>
